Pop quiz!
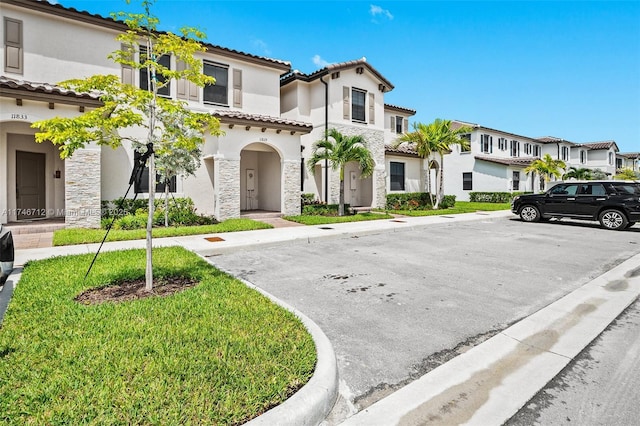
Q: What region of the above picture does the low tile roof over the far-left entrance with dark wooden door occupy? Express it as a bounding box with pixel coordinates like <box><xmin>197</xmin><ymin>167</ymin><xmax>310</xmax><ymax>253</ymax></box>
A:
<box><xmin>0</xmin><ymin>76</ymin><xmax>102</xmax><ymax>105</ymax></box>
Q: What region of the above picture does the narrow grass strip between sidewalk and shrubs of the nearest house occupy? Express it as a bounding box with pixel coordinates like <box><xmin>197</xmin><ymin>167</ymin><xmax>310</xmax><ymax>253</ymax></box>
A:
<box><xmin>53</xmin><ymin>219</ymin><xmax>273</xmax><ymax>246</ymax></box>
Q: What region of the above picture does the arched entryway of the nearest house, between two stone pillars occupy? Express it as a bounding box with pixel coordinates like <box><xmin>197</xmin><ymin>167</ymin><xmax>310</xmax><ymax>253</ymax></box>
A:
<box><xmin>240</xmin><ymin>142</ymin><xmax>282</xmax><ymax>212</ymax></box>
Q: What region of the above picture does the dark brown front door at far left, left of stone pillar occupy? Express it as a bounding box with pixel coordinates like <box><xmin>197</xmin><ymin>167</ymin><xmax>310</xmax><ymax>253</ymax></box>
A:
<box><xmin>16</xmin><ymin>151</ymin><xmax>46</xmax><ymax>220</ymax></box>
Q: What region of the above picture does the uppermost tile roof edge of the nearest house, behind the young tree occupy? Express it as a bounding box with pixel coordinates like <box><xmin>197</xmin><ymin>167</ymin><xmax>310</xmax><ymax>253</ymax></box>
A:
<box><xmin>2</xmin><ymin>0</ymin><xmax>291</xmax><ymax>71</ymax></box>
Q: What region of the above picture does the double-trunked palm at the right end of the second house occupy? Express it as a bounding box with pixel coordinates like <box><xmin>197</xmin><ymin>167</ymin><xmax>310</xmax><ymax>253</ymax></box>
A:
<box><xmin>394</xmin><ymin>118</ymin><xmax>473</xmax><ymax>209</ymax></box>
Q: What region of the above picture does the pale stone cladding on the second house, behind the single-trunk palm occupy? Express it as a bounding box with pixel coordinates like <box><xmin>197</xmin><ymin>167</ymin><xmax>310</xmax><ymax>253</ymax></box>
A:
<box><xmin>329</xmin><ymin>123</ymin><xmax>387</xmax><ymax>208</ymax></box>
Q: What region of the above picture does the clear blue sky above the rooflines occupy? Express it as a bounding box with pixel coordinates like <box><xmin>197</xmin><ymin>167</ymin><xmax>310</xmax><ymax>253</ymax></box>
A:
<box><xmin>59</xmin><ymin>0</ymin><xmax>640</xmax><ymax>152</ymax></box>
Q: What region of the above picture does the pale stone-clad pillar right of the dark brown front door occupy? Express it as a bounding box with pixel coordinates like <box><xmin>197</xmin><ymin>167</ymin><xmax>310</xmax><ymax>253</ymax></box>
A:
<box><xmin>64</xmin><ymin>148</ymin><xmax>101</xmax><ymax>228</ymax></box>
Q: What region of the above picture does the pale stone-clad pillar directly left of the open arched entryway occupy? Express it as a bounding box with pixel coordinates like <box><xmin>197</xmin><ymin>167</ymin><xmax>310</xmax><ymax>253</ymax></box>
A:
<box><xmin>214</xmin><ymin>158</ymin><xmax>240</xmax><ymax>221</ymax></box>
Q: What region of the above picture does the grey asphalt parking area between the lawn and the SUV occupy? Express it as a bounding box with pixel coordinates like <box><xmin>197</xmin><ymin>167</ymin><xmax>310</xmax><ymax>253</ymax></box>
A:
<box><xmin>206</xmin><ymin>216</ymin><xmax>640</xmax><ymax>421</ymax></box>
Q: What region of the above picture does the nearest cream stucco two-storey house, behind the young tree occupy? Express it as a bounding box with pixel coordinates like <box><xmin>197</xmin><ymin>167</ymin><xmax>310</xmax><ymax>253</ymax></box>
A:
<box><xmin>0</xmin><ymin>0</ymin><xmax>312</xmax><ymax>226</ymax></box>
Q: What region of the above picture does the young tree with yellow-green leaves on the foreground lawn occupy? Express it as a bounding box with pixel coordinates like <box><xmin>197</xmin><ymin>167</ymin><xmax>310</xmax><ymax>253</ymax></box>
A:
<box><xmin>33</xmin><ymin>0</ymin><xmax>222</xmax><ymax>291</ymax></box>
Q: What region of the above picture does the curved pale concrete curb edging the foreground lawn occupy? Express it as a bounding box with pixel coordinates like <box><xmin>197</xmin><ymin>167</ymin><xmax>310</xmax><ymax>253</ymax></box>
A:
<box><xmin>200</xmin><ymin>255</ymin><xmax>338</xmax><ymax>426</ymax></box>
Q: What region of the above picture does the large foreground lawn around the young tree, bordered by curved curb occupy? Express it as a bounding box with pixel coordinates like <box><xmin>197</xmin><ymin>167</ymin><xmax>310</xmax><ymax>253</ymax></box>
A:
<box><xmin>0</xmin><ymin>247</ymin><xmax>316</xmax><ymax>425</ymax></box>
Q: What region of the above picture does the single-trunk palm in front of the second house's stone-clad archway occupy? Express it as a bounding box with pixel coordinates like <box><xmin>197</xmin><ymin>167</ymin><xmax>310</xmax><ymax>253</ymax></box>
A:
<box><xmin>307</xmin><ymin>129</ymin><xmax>374</xmax><ymax>216</ymax></box>
